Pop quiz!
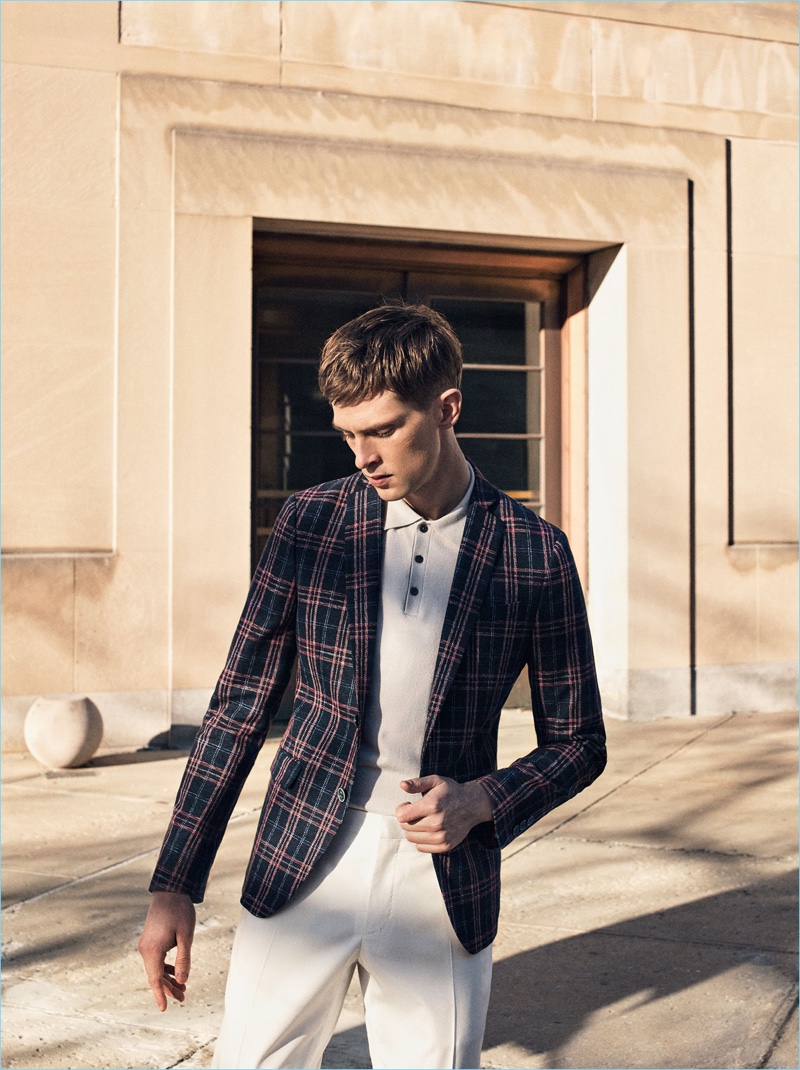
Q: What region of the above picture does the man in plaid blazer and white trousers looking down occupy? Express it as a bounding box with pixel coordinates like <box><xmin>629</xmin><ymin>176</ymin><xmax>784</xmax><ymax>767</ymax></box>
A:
<box><xmin>139</xmin><ymin>306</ymin><xmax>605</xmax><ymax>1068</ymax></box>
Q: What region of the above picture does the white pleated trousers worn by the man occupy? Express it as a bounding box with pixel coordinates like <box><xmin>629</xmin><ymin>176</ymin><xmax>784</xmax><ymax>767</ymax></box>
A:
<box><xmin>213</xmin><ymin>810</ymin><xmax>492</xmax><ymax>1070</ymax></box>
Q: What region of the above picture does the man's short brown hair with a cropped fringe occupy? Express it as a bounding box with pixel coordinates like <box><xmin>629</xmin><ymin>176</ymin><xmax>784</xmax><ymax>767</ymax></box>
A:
<box><xmin>320</xmin><ymin>305</ymin><xmax>461</xmax><ymax>409</ymax></box>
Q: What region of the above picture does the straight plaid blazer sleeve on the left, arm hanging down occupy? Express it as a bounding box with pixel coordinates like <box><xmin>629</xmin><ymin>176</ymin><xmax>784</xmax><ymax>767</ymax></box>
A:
<box><xmin>150</xmin><ymin>499</ymin><xmax>297</xmax><ymax>903</ymax></box>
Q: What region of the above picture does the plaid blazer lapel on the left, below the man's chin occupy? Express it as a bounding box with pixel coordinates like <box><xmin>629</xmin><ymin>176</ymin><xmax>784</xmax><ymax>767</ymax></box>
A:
<box><xmin>344</xmin><ymin>484</ymin><xmax>383</xmax><ymax>713</ymax></box>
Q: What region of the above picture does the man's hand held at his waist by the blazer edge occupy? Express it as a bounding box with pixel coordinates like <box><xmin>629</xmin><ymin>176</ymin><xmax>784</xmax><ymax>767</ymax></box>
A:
<box><xmin>395</xmin><ymin>776</ymin><xmax>492</xmax><ymax>855</ymax></box>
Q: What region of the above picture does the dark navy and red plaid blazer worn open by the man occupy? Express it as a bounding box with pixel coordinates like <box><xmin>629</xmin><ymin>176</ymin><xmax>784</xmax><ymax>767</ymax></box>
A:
<box><xmin>151</xmin><ymin>473</ymin><xmax>605</xmax><ymax>953</ymax></box>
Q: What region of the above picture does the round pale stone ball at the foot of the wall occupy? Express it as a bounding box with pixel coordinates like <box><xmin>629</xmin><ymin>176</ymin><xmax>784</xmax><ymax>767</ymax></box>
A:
<box><xmin>25</xmin><ymin>698</ymin><xmax>103</xmax><ymax>769</ymax></box>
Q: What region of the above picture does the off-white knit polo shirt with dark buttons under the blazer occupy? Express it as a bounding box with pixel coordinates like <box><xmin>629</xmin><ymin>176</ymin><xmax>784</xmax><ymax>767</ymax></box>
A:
<box><xmin>350</xmin><ymin>469</ymin><xmax>475</xmax><ymax>815</ymax></box>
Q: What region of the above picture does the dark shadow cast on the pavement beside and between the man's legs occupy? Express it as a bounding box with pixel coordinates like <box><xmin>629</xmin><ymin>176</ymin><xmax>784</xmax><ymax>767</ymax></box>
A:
<box><xmin>322</xmin><ymin>873</ymin><xmax>797</xmax><ymax>1067</ymax></box>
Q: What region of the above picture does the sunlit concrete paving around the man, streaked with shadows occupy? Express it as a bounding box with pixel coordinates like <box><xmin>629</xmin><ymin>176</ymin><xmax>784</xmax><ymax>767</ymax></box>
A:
<box><xmin>2</xmin><ymin>710</ymin><xmax>798</xmax><ymax>1068</ymax></box>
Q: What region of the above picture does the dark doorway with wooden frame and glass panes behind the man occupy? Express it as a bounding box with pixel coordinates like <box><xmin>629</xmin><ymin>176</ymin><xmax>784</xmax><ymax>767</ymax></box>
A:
<box><xmin>251</xmin><ymin>232</ymin><xmax>580</xmax><ymax>568</ymax></box>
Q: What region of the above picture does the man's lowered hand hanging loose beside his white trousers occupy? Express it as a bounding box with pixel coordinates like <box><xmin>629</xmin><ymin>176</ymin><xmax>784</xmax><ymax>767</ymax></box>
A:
<box><xmin>139</xmin><ymin>891</ymin><xmax>195</xmax><ymax>1010</ymax></box>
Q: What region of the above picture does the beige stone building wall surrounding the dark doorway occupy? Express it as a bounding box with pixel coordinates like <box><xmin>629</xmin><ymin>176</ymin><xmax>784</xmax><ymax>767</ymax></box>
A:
<box><xmin>2</xmin><ymin>2</ymin><xmax>798</xmax><ymax>745</ymax></box>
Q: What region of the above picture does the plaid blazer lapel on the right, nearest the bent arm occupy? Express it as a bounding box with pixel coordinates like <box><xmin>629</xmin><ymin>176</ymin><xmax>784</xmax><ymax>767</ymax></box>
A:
<box><xmin>425</xmin><ymin>472</ymin><xmax>506</xmax><ymax>742</ymax></box>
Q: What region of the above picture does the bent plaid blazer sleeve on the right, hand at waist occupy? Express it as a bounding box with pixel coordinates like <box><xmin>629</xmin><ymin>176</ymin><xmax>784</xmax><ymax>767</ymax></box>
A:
<box><xmin>480</xmin><ymin>532</ymin><xmax>605</xmax><ymax>847</ymax></box>
